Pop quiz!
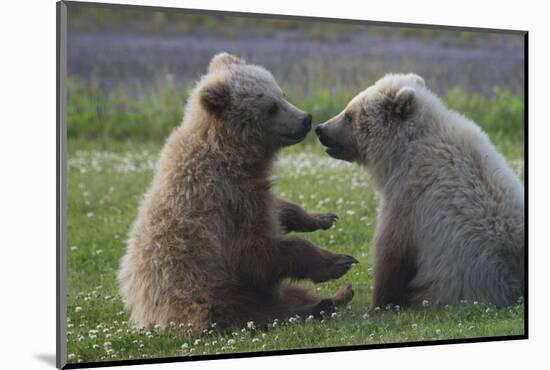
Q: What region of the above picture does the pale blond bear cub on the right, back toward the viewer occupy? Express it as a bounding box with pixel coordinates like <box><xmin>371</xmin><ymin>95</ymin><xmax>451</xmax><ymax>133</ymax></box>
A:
<box><xmin>316</xmin><ymin>74</ymin><xmax>525</xmax><ymax>307</ymax></box>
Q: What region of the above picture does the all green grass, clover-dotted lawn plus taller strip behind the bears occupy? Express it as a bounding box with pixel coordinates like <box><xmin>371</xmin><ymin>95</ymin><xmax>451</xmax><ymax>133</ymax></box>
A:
<box><xmin>67</xmin><ymin>81</ymin><xmax>524</xmax><ymax>362</ymax></box>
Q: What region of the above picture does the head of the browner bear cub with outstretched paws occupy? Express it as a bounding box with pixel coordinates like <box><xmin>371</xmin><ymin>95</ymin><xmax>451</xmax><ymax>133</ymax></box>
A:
<box><xmin>197</xmin><ymin>53</ymin><xmax>311</xmax><ymax>149</ymax></box>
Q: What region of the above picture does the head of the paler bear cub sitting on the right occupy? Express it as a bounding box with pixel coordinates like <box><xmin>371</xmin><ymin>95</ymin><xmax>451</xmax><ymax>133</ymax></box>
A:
<box><xmin>315</xmin><ymin>73</ymin><xmax>425</xmax><ymax>165</ymax></box>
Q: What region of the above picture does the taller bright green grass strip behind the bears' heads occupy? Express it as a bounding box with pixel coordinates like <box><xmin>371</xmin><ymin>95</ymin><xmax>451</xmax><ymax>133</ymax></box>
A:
<box><xmin>67</xmin><ymin>76</ymin><xmax>524</xmax><ymax>152</ymax></box>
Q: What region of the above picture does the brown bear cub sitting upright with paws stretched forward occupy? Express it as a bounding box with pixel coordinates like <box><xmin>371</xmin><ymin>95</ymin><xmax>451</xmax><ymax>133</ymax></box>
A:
<box><xmin>118</xmin><ymin>53</ymin><xmax>357</xmax><ymax>331</ymax></box>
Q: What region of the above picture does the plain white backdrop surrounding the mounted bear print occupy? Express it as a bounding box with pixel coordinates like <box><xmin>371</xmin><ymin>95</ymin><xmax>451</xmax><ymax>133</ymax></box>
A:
<box><xmin>0</xmin><ymin>0</ymin><xmax>550</xmax><ymax>370</ymax></box>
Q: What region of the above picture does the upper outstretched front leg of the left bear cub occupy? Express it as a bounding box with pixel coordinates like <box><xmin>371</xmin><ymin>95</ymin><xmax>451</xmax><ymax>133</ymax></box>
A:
<box><xmin>276</xmin><ymin>199</ymin><xmax>338</xmax><ymax>233</ymax></box>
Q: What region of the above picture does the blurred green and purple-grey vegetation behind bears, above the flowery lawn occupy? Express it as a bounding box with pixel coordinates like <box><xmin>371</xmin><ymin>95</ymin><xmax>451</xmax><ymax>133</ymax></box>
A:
<box><xmin>68</xmin><ymin>5</ymin><xmax>524</xmax><ymax>150</ymax></box>
